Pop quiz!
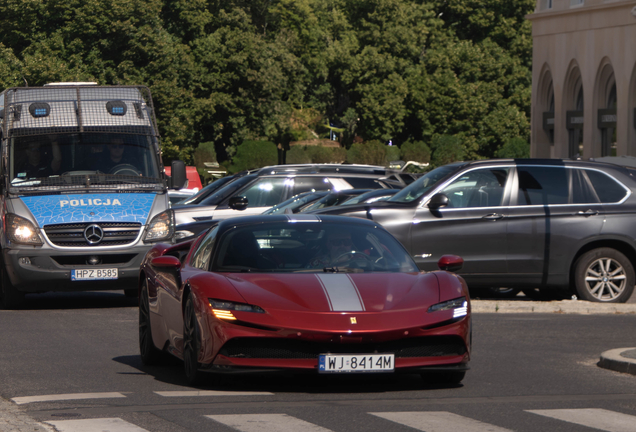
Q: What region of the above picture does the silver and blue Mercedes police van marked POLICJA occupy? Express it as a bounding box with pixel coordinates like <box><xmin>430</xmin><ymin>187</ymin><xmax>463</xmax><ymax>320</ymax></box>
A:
<box><xmin>0</xmin><ymin>83</ymin><xmax>185</xmax><ymax>309</ymax></box>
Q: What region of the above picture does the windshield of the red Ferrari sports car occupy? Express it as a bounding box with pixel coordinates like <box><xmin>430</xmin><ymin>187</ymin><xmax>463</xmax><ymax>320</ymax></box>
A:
<box><xmin>212</xmin><ymin>220</ymin><xmax>418</xmax><ymax>273</ymax></box>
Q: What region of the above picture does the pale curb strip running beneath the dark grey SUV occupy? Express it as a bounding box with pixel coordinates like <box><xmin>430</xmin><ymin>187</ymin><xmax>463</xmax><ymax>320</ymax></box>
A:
<box><xmin>470</xmin><ymin>300</ymin><xmax>636</xmax><ymax>315</ymax></box>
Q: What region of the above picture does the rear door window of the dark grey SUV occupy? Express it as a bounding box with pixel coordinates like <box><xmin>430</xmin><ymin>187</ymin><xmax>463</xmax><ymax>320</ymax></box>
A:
<box><xmin>517</xmin><ymin>166</ymin><xmax>569</xmax><ymax>205</ymax></box>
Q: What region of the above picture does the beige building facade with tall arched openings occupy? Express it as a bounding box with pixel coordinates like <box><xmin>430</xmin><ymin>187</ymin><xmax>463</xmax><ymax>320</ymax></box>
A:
<box><xmin>527</xmin><ymin>0</ymin><xmax>636</xmax><ymax>158</ymax></box>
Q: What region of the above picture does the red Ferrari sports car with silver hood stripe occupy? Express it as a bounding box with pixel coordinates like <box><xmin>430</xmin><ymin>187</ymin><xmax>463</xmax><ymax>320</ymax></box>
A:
<box><xmin>139</xmin><ymin>215</ymin><xmax>471</xmax><ymax>384</ymax></box>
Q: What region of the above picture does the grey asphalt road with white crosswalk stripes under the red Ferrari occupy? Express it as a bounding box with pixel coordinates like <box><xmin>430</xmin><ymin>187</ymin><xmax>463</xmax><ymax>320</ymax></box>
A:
<box><xmin>0</xmin><ymin>292</ymin><xmax>636</xmax><ymax>432</ymax></box>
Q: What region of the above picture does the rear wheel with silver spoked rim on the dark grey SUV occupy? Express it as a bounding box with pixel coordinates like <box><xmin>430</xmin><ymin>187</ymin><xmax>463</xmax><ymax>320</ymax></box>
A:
<box><xmin>574</xmin><ymin>248</ymin><xmax>634</xmax><ymax>303</ymax></box>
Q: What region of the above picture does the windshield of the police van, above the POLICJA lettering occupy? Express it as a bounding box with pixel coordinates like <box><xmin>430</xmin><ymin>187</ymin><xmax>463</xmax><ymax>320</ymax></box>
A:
<box><xmin>9</xmin><ymin>133</ymin><xmax>163</xmax><ymax>190</ymax></box>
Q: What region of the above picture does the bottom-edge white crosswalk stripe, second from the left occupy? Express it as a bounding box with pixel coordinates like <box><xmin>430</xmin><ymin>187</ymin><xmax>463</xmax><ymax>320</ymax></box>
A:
<box><xmin>205</xmin><ymin>414</ymin><xmax>331</xmax><ymax>432</ymax></box>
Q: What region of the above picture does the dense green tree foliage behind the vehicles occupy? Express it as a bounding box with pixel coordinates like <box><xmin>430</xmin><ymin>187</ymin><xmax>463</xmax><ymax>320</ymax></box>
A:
<box><xmin>0</xmin><ymin>0</ymin><xmax>535</xmax><ymax>163</ymax></box>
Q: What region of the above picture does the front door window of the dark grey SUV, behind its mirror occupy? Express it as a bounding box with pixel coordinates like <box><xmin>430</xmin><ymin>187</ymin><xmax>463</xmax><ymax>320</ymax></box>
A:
<box><xmin>441</xmin><ymin>168</ymin><xmax>509</xmax><ymax>208</ymax></box>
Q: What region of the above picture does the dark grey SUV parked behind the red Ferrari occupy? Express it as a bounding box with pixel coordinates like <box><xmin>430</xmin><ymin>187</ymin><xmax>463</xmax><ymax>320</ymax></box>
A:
<box><xmin>314</xmin><ymin>159</ymin><xmax>636</xmax><ymax>302</ymax></box>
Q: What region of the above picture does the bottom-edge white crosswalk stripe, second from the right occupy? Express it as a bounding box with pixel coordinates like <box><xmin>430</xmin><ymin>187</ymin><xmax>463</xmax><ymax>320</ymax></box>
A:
<box><xmin>369</xmin><ymin>411</ymin><xmax>511</xmax><ymax>432</ymax></box>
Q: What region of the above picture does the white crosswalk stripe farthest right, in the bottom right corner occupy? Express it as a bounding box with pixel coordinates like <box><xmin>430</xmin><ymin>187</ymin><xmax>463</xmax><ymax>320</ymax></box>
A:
<box><xmin>526</xmin><ymin>408</ymin><xmax>636</xmax><ymax>432</ymax></box>
